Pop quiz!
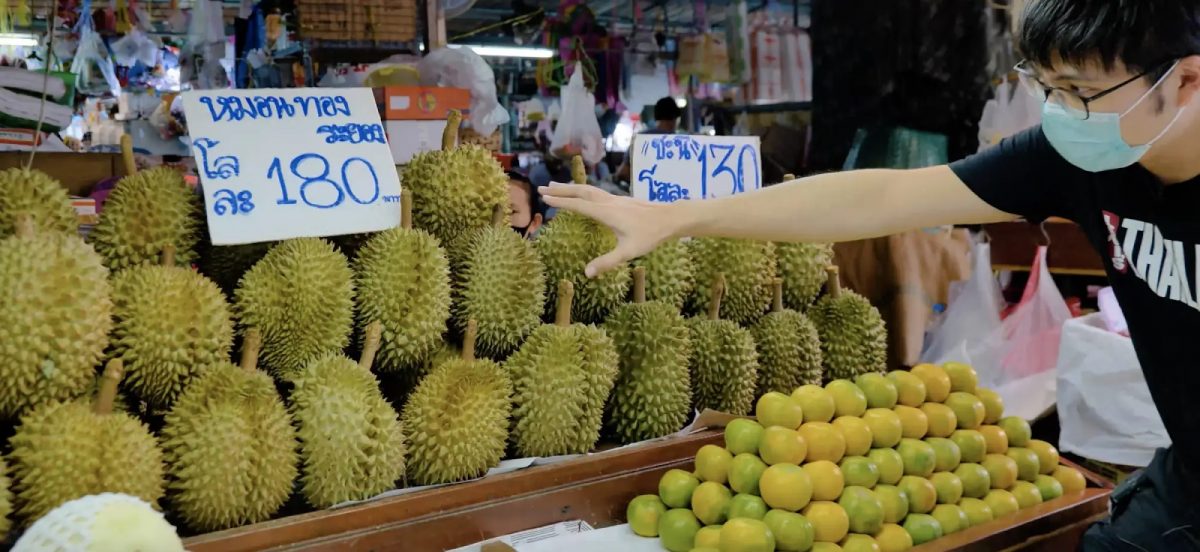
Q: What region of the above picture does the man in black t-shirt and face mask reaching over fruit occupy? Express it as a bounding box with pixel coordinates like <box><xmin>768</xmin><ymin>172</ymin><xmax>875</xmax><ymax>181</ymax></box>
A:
<box><xmin>544</xmin><ymin>0</ymin><xmax>1200</xmax><ymax>551</ymax></box>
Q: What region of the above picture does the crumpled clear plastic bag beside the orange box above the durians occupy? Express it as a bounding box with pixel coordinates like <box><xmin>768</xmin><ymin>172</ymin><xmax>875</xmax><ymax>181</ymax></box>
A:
<box><xmin>416</xmin><ymin>48</ymin><xmax>508</xmax><ymax>136</ymax></box>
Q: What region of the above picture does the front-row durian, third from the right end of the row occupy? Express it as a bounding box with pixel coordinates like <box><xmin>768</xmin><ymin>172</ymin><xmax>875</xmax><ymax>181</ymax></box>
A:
<box><xmin>688</xmin><ymin>274</ymin><xmax>758</xmax><ymax>416</ymax></box>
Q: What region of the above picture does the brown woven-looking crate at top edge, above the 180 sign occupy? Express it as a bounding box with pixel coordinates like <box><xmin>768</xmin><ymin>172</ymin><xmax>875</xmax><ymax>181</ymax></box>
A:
<box><xmin>296</xmin><ymin>0</ymin><xmax>418</xmax><ymax>43</ymax></box>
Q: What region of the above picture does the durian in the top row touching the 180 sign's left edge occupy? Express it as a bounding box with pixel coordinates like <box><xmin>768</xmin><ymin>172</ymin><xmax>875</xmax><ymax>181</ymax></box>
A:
<box><xmin>90</xmin><ymin>167</ymin><xmax>200</xmax><ymax>271</ymax></box>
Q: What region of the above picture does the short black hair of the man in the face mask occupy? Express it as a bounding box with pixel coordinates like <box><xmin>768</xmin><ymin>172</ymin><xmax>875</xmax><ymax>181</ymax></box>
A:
<box><xmin>1018</xmin><ymin>0</ymin><xmax>1200</xmax><ymax>80</ymax></box>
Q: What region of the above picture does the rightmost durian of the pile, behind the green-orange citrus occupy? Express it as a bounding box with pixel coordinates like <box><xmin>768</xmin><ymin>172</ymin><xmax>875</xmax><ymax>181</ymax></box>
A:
<box><xmin>809</xmin><ymin>266</ymin><xmax>888</xmax><ymax>380</ymax></box>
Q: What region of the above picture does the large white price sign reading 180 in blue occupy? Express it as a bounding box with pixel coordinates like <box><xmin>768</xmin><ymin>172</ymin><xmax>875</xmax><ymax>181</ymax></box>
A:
<box><xmin>184</xmin><ymin>88</ymin><xmax>400</xmax><ymax>245</ymax></box>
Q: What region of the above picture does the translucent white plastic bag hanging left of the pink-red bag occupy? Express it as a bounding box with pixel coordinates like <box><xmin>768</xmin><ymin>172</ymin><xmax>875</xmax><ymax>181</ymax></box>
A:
<box><xmin>920</xmin><ymin>241</ymin><xmax>1004</xmax><ymax>364</ymax></box>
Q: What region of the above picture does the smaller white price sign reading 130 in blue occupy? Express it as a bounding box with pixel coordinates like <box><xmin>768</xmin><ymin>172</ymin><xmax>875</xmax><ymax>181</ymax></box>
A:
<box><xmin>630</xmin><ymin>134</ymin><xmax>762</xmax><ymax>203</ymax></box>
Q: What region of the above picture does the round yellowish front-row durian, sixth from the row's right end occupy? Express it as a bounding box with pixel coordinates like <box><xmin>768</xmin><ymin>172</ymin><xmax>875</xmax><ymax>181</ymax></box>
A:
<box><xmin>402</xmin><ymin>320</ymin><xmax>513</xmax><ymax>485</ymax></box>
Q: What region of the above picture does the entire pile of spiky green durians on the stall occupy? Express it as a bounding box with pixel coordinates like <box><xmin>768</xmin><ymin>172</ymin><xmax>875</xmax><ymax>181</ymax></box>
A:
<box><xmin>0</xmin><ymin>124</ymin><xmax>887</xmax><ymax>542</ymax></box>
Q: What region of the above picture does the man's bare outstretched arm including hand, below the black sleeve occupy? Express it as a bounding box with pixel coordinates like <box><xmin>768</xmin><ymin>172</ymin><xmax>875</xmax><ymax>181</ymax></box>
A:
<box><xmin>542</xmin><ymin>166</ymin><xmax>1016</xmax><ymax>276</ymax></box>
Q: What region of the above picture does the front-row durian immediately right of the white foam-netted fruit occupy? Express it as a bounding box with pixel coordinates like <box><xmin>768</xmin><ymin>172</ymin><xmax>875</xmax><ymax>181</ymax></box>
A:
<box><xmin>161</xmin><ymin>329</ymin><xmax>298</xmax><ymax>532</ymax></box>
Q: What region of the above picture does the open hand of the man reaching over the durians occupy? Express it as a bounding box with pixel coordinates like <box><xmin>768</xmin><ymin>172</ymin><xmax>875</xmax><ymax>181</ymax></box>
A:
<box><xmin>539</xmin><ymin>182</ymin><xmax>676</xmax><ymax>278</ymax></box>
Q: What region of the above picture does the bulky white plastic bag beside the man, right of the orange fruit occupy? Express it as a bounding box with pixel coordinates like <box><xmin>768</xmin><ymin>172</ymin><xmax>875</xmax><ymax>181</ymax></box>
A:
<box><xmin>1057</xmin><ymin>313</ymin><xmax>1171</xmax><ymax>467</ymax></box>
